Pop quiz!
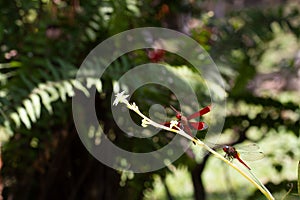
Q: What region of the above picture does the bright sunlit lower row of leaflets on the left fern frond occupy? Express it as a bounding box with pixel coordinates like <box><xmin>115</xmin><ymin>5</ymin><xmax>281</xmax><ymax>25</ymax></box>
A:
<box><xmin>9</xmin><ymin>78</ymin><xmax>102</xmax><ymax>129</ymax></box>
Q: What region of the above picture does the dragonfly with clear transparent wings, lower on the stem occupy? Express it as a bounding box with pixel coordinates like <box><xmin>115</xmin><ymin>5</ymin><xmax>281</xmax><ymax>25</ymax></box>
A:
<box><xmin>223</xmin><ymin>144</ymin><xmax>264</xmax><ymax>170</ymax></box>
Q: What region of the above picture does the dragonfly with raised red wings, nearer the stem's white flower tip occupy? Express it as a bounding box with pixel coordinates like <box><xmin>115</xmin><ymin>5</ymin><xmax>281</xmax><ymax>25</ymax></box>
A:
<box><xmin>164</xmin><ymin>105</ymin><xmax>211</xmax><ymax>137</ymax></box>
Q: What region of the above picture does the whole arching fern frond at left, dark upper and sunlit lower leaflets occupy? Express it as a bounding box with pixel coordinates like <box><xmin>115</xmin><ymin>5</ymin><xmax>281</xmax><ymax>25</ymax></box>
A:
<box><xmin>0</xmin><ymin>59</ymin><xmax>102</xmax><ymax>142</ymax></box>
